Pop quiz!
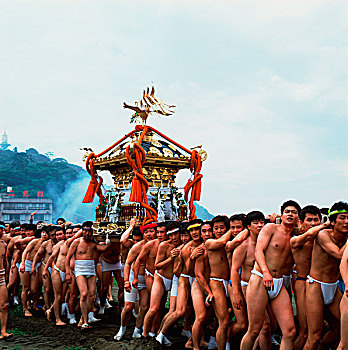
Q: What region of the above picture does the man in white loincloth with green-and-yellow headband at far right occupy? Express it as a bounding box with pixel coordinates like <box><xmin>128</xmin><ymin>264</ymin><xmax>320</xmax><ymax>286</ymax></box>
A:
<box><xmin>304</xmin><ymin>202</ymin><xmax>348</xmax><ymax>350</ymax></box>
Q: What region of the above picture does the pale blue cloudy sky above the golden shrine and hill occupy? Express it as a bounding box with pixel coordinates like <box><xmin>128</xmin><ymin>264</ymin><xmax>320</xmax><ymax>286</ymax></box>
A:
<box><xmin>0</xmin><ymin>0</ymin><xmax>348</xmax><ymax>215</ymax></box>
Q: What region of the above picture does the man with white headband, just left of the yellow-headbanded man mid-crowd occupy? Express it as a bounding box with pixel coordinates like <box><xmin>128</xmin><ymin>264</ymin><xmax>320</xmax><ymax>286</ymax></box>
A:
<box><xmin>143</xmin><ymin>223</ymin><xmax>181</xmax><ymax>343</ymax></box>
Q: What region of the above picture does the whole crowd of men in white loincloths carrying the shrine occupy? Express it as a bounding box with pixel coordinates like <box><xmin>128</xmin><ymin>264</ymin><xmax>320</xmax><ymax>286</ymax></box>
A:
<box><xmin>0</xmin><ymin>200</ymin><xmax>348</xmax><ymax>350</ymax></box>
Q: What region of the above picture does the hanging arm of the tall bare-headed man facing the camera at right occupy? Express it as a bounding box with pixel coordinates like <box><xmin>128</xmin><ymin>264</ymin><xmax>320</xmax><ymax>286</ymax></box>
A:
<box><xmin>255</xmin><ymin>224</ymin><xmax>276</xmax><ymax>290</ymax></box>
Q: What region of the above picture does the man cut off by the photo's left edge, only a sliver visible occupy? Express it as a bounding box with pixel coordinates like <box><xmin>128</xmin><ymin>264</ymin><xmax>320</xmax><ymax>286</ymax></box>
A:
<box><xmin>0</xmin><ymin>221</ymin><xmax>12</xmax><ymax>340</ymax></box>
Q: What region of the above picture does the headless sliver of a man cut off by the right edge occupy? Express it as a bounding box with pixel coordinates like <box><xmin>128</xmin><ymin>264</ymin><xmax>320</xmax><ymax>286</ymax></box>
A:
<box><xmin>338</xmin><ymin>243</ymin><xmax>348</xmax><ymax>350</ymax></box>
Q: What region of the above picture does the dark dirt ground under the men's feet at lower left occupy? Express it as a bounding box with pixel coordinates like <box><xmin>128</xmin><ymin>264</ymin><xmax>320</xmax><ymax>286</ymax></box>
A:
<box><xmin>0</xmin><ymin>306</ymin><xmax>192</xmax><ymax>350</ymax></box>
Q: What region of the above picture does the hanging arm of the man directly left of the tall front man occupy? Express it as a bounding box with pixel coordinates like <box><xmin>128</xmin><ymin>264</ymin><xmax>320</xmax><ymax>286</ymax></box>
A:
<box><xmin>230</xmin><ymin>244</ymin><xmax>246</xmax><ymax>310</ymax></box>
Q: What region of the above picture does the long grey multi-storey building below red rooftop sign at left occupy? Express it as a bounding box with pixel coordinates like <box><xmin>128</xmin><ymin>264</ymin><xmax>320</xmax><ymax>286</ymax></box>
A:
<box><xmin>0</xmin><ymin>194</ymin><xmax>53</xmax><ymax>223</ymax></box>
